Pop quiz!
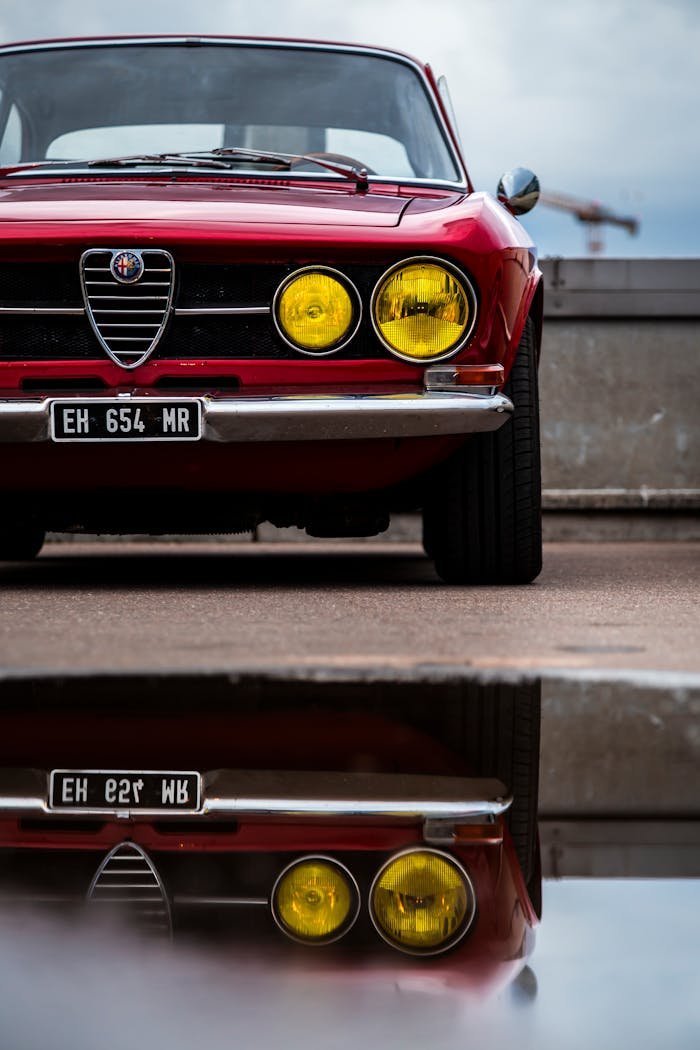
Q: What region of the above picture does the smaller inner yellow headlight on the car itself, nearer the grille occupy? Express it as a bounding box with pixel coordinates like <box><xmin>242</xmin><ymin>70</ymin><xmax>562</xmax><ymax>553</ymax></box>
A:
<box><xmin>275</xmin><ymin>270</ymin><xmax>359</xmax><ymax>354</ymax></box>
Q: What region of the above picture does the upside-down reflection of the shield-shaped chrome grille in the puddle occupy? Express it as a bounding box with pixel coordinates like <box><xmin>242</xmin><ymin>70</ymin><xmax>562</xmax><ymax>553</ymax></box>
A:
<box><xmin>87</xmin><ymin>842</ymin><xmax>171</xmax><ymax>935</ymax></box>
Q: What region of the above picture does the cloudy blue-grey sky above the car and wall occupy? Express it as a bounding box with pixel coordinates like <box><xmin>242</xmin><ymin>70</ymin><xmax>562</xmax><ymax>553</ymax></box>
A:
<box><xmin>0</xmin><ymin>0</ymin><xmax>700</xmax><ymax>256</ymax></box>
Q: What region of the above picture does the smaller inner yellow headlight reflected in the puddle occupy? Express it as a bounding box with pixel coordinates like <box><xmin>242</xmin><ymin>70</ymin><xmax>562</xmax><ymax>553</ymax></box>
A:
<box><xmin>272</xmin><ymin>857</ymin><xmax>360</xmax><ymax>944</ymax></box>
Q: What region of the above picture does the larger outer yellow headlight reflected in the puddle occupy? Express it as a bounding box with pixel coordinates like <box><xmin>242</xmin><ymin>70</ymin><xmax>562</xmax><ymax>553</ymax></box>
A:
<box><xmin>369</xmin><ymin>849</ymin><xmax>474</xmax><ymax>954</ymax></box>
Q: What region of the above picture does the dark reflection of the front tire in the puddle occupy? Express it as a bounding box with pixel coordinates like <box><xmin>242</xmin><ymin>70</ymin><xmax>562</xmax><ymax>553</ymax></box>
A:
<box><xmin>465</xmin><ymin>680</ymin><xmax>542</xmax><ymax>911</ymax></box>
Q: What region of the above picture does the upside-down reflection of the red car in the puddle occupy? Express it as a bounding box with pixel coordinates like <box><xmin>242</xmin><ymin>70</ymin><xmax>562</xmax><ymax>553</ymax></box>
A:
<box><xmin>0</xmin><ymin>675</ymin><xmax>539</xmax><ymax>988</ymax></box>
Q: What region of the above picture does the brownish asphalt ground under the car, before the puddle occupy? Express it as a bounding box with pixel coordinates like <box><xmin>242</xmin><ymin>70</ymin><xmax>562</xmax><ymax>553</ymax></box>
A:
<box><xmin>0</xmin><ymin>543</ymin><xmax>700</xmax><ymax>673</ymax></box>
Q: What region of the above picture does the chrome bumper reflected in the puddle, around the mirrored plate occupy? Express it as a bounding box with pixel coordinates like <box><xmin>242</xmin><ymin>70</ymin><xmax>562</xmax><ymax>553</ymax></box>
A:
<box><xmin>0</xmin><ymin>769</ymin><xmax>512</xmax><ymax>823</ymax></box>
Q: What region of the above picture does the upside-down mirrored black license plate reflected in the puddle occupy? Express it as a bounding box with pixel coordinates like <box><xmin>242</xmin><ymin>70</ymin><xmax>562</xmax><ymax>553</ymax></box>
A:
<box><xmin>48</xmin><ymin>770</ymin><xmax>199</xmax><ymax>811</ymax></box>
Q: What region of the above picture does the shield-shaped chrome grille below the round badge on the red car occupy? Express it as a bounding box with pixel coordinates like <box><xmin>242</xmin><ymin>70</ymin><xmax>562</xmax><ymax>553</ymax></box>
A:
<box><xmin>81</xmin><ymin>249</ymin><xmax>174</xmax><ymax>368</ymax></box>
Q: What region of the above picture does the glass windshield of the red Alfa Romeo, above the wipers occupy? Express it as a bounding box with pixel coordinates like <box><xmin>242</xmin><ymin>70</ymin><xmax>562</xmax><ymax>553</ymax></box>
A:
<box><xmin>0</xmin><ymin>42</ymin><xmax>462</xmax><ymax>182</ymax></box>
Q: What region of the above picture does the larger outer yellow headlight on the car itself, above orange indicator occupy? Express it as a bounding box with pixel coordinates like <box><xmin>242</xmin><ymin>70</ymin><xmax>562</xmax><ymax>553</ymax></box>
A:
<box><xmin>373</xmin><ymin>259</ymin><xmax>473</xmax><ymax>361</ymax></box>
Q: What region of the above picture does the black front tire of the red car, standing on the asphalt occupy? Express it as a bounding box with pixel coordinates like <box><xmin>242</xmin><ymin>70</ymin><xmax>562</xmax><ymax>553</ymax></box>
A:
<box><xmin>423</xmin><ymin>319</ymin><xmax>542</xmax><ymax>584</ymax></box>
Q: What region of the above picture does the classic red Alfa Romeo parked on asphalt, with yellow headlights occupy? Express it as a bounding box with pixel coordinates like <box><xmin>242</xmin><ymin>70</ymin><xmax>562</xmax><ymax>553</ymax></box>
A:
<box><xmin>0</xmin><ymin>38</ymin><xmax>542</xmax><ymax>583</ymax></box>
